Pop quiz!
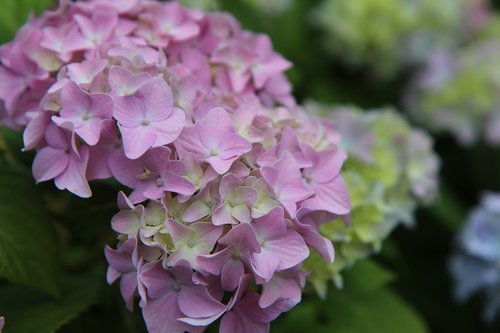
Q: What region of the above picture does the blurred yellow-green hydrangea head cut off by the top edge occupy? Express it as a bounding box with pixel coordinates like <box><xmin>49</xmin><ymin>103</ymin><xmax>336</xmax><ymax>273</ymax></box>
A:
<box><xmin>315</xmin><ymin>0</ymin><xmax>484</xmax><ymax>78</ymax></box>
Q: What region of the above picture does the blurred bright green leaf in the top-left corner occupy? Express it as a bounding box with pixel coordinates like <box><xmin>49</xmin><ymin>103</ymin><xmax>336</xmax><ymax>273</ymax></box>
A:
<box><xmin>0</xmin><ymin>0</ymin><xmax>54</xmax><ymax>43</ymax></box>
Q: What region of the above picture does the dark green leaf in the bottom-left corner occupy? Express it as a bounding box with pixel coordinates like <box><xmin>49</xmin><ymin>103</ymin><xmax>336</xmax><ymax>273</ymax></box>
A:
<box><xmin>0</xmin><ymin>274</ymin><xmax>103</xmax><ymax>333</ymax></box>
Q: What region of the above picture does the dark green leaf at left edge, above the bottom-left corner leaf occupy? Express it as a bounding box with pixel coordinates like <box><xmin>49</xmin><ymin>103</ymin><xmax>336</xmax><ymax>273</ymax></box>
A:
<box><xmin>0</xmin><ymin>161</ymin><xmax>59</xmax><ymax>296</ymax></box>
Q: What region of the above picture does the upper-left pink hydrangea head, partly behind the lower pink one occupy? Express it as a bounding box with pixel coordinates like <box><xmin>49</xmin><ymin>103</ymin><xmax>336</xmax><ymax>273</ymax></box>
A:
<box><xmin>0</xmin><ymin>0</ymin><xmax>294</xmax><ymax>197</ymax></box>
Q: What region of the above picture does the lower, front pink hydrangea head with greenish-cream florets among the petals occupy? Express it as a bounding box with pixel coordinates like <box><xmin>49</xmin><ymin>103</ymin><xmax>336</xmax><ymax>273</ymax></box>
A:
<box><xmin>106</xmin><ymin>99</ymin><xmax>350</xmax><ymax>332</ymax></box>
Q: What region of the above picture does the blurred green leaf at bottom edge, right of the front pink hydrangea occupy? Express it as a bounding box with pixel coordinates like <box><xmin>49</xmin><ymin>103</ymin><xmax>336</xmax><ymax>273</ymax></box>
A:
<box><xmin>271</xmin><ymin>260</ymin><xmax>428</xmax><ymax>333</ymax></box>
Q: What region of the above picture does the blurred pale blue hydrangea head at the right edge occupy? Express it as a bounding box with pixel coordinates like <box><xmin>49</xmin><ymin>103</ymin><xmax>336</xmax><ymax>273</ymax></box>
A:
<box><xmin>450</xmin><ymin>193</ymin><xmax>500</xmax><ymax>321</ymax></box>
